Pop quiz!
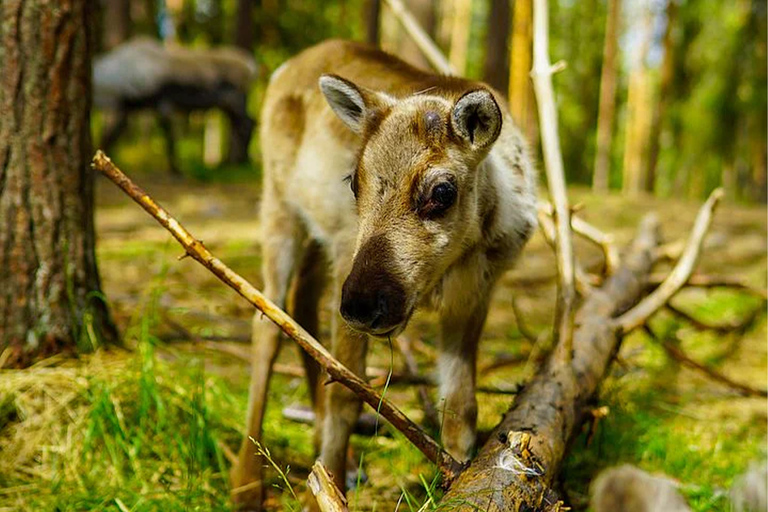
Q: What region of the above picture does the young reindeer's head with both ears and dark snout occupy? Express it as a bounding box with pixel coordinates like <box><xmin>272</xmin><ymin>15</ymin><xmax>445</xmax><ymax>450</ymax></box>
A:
<box><xmin>320</xmin><ymin>75</ymin><xmax>502</xmax><ymax>336</ymax></box>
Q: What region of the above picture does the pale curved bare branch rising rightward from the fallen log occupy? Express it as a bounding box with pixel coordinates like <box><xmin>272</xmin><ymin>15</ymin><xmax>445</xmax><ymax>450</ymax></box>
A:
<box><xmin>614</xmin><ymin>188</ymin><xmax>723</xmax><ymax>333</ymax></box>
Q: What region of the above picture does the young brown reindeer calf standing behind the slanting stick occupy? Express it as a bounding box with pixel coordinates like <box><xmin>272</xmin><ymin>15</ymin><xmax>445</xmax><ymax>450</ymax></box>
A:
<box><xmin>232</xmin><ymin>41</ymin><xmax>536</xmax><ymax>508</ymax></box>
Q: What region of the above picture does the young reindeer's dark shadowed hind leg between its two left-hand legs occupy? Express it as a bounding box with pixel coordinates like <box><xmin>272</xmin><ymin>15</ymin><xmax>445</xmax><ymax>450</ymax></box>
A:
<box><xmin>291</xmin><ymin>241</ymin><xmax>328</xmax><ymax>450</ymax></box>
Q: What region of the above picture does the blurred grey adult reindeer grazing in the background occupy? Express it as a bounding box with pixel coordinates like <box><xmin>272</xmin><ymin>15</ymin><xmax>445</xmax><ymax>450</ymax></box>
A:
<box><xmin>93</xmin><ymin>37</ymin><xmax>256</xmax><ymax>175</ymax></box>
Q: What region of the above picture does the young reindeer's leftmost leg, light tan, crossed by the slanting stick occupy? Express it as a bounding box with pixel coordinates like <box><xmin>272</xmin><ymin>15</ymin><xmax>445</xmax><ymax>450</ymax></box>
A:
<box><xmin>231</xmin><ymin>190</ymin><xmax>302</xmax><ymax>510</ymax></box>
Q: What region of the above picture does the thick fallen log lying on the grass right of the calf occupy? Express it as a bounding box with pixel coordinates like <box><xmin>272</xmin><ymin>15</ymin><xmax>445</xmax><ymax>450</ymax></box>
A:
<box><xmin>443</xmin><ymin>217</ymin><xmax>659</xmax><ymax>512</ymax></box>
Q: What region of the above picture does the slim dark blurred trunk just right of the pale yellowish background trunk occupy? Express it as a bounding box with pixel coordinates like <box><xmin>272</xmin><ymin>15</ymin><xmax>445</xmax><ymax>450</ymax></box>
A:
<box><xmin>643</xmin><ymin>0</ymin><xmax>677</xmax><ymax>193</ymax></box>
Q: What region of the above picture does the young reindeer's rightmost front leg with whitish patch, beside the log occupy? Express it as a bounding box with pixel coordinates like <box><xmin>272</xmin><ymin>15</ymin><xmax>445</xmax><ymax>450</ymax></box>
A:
<box><xmin>438</xmin><ymin>265</ymin><xmax>492</xmax><ymax>461</ymax></box>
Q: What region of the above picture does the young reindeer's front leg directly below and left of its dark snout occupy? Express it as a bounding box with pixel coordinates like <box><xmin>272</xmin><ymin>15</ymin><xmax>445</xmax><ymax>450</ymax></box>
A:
<box><xmin>320</xmin><ymin>258</ymin><xmax>368</xmax><ymax>490</ymax></box>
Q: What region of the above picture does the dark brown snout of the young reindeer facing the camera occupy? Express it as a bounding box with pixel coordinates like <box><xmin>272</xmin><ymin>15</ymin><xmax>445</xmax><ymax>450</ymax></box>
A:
<box><xmin>341</xmin><ymin>235</ymin><xmax>406</xmax><ymax>335</ymax></box>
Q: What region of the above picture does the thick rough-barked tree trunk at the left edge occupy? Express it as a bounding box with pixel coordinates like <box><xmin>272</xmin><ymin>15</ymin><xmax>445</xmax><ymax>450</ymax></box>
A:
<box><xmin>0</xmin><ymin>0</ymin><xmax>117</xmax><ymax>365</ymax></box>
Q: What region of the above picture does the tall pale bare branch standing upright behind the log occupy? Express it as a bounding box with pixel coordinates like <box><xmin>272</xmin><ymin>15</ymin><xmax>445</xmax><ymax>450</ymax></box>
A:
<box><xmin>531</xmin><ymin>0</ymin><xmax>576</xmax><ymax>358</ymax></box>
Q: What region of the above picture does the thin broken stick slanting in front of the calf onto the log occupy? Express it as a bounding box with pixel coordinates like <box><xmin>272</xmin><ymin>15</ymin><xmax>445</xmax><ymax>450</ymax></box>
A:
<box><xmin>93</xmin><ymin>151</ymin><xmax>462</xmax><ymax>480</ymax></box>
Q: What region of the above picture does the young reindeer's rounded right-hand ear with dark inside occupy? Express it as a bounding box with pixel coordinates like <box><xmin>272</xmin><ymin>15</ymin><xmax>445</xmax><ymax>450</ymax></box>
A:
<box><xmin>451</xmin><ymin>89</ymin><xmax>501</xmax><ymax>149</ymax></box>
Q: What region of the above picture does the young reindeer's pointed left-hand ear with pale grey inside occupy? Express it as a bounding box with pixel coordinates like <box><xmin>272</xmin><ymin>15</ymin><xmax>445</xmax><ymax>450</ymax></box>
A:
<box><xmin>320</xmin><ymin>75</ymin><xmax>385</xmax><ymax>133</ymax></box>
